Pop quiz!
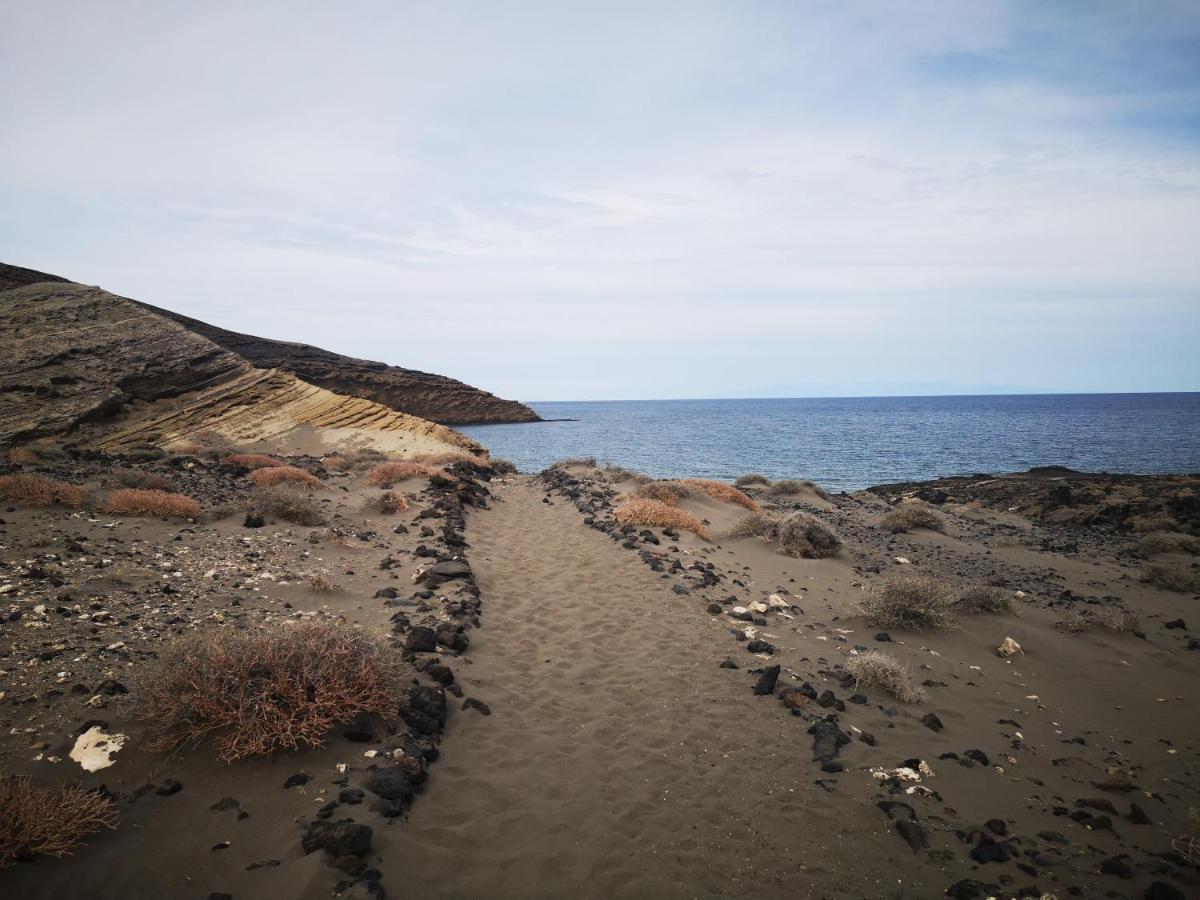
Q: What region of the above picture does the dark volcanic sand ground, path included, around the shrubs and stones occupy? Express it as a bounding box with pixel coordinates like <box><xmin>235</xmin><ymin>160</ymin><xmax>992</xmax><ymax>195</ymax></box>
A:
<box><xmin>0</xmin><ymin>458</ymin><xmax>1200</xmax><ymax>898</ymax></box>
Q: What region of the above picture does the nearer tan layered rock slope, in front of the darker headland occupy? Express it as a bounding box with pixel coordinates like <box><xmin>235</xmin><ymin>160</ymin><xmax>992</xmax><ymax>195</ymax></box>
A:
<box><xmin>0</xmin><ymin>266</ymin><xmax>480</xmax><ymax>454</ymax></box>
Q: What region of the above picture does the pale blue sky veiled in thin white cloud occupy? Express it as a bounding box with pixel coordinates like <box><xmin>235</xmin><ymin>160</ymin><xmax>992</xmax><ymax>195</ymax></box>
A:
<box><xmin>0</xmin><ymin>0</ymin><xmax>1200</xmax><ymax>401</ymax></box>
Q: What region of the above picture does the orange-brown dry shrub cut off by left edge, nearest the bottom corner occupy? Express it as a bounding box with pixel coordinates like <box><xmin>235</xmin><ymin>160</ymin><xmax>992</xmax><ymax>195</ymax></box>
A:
<box><xmin>0</xmin><ymin>776</ymin><xmax>119</xmax><ymax>869</ymax></box>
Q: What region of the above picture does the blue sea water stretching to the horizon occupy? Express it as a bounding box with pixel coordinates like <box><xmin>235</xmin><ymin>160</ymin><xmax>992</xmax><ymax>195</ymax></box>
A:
<box><xmin>461</xmin><ymin>394</ymin><xmax>1200</xmax><ymax>491</ymax></box>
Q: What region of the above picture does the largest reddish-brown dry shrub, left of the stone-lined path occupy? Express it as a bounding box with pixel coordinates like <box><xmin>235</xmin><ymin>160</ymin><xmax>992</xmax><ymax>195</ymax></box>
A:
<box><xmin>140</xmin><ymin>622</ymin><xmax>400</xmax><ymax>763</ymax></box>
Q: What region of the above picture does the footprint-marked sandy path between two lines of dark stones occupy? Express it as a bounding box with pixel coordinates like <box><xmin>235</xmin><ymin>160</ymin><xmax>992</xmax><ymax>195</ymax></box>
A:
<box><xmin>377</xmin><ymin>478</ymin><xmax>911</xmax><ymax>898</ymax></box>
